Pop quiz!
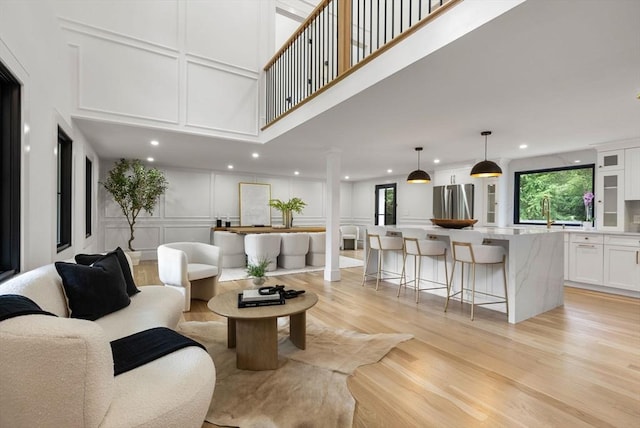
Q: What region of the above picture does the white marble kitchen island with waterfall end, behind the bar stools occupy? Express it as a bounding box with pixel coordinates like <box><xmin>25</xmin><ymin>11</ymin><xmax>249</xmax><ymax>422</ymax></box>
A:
<box><xmin>364</xmin><ymin>226</ymin><xmax>564</xmax><ymax>324</ymax></box>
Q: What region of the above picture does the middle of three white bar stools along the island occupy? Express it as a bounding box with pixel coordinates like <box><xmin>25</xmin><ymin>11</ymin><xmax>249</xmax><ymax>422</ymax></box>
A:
<box><xmin>398</xmin><ymin>237</ymin><xmax>449</xmax><ymax>303</ymax></box>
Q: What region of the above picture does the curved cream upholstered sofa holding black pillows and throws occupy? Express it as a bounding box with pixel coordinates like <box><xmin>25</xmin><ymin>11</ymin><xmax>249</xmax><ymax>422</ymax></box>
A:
<box><xmin>0</xmin><ymin>256</ymin><xmax>216</xmax><ymax>427</ymax></box>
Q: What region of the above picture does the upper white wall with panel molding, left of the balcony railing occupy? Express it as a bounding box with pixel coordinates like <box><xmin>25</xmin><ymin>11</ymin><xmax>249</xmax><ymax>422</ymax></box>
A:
<box><xmin>56</xmin><ymin>0</ymin><xmax>275</xmax><ymax>141</ymax></box>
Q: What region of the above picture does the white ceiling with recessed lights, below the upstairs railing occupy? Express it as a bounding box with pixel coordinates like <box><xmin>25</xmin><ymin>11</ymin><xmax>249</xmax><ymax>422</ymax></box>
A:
<box><xmin>77</xmin><ymin>0</ymin><xmax>640</xmax><ymax>180</ymax></box>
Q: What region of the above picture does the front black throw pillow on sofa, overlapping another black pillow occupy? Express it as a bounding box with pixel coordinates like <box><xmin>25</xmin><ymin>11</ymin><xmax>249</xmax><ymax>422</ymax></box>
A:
<box><xmin>55</xmin><ymin>254</ymin><xmax>131</xmax><ymax>321</ymax></box>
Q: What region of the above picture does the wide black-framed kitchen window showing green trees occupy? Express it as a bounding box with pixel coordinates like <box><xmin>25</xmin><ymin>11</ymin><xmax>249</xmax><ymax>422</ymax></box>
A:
<box><xmin>513</xmin><ymin>164</ymin><xmax>594</xmax><ymax>226</ymax></box>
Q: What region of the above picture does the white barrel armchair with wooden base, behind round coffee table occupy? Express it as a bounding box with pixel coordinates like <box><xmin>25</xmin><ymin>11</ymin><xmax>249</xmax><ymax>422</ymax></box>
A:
<box><xmin>158</xmin><ymin>242</ymin><xmax>222</xmax><ymax>311</ymax></box>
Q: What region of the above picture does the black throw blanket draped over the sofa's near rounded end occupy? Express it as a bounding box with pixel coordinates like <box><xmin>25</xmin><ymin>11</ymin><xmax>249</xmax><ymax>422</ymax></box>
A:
<box><xmin>111</xmin><ymin>327</ymin><xmax>206</xmax><ymax>376</ymax></box>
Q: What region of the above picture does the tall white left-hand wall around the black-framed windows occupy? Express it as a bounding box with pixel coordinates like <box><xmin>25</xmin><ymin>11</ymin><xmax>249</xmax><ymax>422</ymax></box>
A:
<box><xmin>0</xmin><ymin>0</ymin><xmax>101</xmax><ymax>270</ymax></box>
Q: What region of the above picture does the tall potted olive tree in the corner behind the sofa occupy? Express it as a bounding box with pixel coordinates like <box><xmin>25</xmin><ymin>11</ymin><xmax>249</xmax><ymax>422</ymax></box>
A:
<box><xmin>100</xmin><ymin>159</ymin><xmax>168</xmax><ymax>264</ymax></box>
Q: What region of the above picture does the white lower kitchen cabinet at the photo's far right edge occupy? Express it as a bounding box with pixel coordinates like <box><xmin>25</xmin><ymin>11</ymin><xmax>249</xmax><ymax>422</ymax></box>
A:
<box><xmin>604</xmin><ymin>235</ymin><xmax>640</xmax><ymax>291</ymax></box>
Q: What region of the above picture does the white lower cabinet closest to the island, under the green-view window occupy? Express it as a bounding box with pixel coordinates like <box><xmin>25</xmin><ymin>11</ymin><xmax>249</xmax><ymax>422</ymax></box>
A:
<box><xmin>569</xmin><ymin>233</ymin><xmax>604</xmax><ymax>285</ymax></box>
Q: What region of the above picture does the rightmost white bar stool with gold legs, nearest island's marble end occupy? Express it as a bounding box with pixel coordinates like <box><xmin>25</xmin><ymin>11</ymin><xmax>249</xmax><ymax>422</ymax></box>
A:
<box><xmin>444</xmin><ymin>241</ymin><xmax>509</xmax><ymax>321</ymax></box>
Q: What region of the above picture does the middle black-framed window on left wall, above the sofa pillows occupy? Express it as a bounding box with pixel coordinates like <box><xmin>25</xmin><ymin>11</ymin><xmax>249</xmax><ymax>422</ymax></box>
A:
<box><xmin>56</xmin><ymin>126</ymin><xmax>73</xmax><ymax>253</ymax></box>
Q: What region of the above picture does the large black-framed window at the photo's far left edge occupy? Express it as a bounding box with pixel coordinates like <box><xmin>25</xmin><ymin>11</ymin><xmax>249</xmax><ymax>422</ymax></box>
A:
<box><xmin>0</xmin><ymin>62</ymin><xmax>22</xmax><ymax>281</ymax></box>
